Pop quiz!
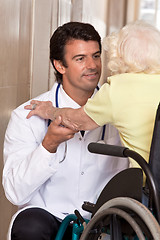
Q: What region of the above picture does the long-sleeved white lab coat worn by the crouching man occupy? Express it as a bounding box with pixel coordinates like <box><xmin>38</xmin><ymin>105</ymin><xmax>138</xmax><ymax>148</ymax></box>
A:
<box><xmin>3</xmin><ymin>83</ymin><xmax>128</xmax><ymax>238</ymax></box>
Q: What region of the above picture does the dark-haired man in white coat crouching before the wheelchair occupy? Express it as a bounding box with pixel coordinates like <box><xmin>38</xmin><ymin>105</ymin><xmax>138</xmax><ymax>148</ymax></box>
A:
<box><xmin>3</xmin><ymin>22</ymin><xmax>128</xmax><ymax>240</ymax></box>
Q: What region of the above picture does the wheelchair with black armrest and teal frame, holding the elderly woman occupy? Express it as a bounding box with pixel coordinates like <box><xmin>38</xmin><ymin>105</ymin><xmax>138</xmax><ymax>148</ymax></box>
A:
<box><xmin>55</xmin><ymin>104</ymin><xmax>160</xmax><ymax>240</ymax></box>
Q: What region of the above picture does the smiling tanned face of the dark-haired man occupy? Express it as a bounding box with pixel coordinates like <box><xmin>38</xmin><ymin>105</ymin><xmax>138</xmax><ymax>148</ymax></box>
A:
<box><xmin>63</xmin><ymin>39</ymin><xmax>101</xmax><ymax>93</ymax></box>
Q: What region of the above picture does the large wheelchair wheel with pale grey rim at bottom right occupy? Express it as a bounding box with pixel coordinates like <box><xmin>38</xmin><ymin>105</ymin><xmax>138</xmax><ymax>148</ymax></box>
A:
<box><xmin>80</xmin><ymin>197</ymin><xmax>160</xmax><ymax>240</ymax></box>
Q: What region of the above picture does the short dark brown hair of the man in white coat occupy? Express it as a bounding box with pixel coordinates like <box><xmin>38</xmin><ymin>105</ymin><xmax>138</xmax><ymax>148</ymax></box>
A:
<box><xmin>50</xmin><ymin>22</ymin><xmax>102</xmax><ymax>83</ymax></box>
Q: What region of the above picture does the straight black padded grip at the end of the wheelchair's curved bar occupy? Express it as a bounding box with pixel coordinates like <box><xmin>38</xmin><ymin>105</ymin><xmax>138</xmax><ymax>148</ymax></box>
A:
<box><xmin>88</xmin><ymin>142</ymin><xmax>128</xmax><ymax>157</ymax></box>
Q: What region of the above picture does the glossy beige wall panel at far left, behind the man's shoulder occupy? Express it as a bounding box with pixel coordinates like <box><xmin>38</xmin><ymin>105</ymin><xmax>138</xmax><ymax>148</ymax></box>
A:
<box><xmin>0</xmin><ymin>0</ymin><xmax>32</xmax><ymax>240</ymax></box>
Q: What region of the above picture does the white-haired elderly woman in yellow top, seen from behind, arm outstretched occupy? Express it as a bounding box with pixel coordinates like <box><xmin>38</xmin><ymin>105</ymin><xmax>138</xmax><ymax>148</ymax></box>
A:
<box><xmin>26</xmin><ymin>21</ymin><xmax>160</xmax><ymax>169</ymax></box>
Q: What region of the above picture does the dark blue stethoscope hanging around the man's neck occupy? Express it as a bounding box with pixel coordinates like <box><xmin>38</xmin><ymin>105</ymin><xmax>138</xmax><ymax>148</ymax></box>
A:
<box><xmin>48</xmin><ymin>83</ymin><xmax>106</xmax><ymax>163</ymax></box>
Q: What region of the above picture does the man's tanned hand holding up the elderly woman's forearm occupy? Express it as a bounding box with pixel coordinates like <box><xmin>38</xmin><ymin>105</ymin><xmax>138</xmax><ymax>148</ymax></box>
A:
<box><xmin>42</xmin><ymin>116</ymin><xmax>77</xmax><ymax>153</ymax></box>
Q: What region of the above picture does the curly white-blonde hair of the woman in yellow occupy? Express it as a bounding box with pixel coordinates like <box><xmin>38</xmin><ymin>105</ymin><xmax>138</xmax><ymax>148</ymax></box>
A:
<box><xmin>103</xmin><ymin>21</ymin><xmax>160</xmax><ymax>75</ymax></box>
